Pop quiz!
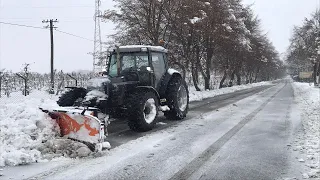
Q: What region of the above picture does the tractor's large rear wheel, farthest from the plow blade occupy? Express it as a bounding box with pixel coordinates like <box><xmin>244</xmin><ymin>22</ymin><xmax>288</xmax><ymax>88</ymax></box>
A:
<box><xmin>164</xmin><ymin>76</ymin><xmax>189</xmax><ymax>120</ymax></box>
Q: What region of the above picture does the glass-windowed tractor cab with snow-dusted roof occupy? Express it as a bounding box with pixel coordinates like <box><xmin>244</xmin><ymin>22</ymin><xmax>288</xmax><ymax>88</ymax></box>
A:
<box><xmin>107</xmin><ymin>46</ymin><xmax>168</xmax><ymax>89</ymax></box>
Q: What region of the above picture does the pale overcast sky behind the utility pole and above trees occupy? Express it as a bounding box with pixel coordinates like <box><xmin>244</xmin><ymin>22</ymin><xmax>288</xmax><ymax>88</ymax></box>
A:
<box><xmin>0</xmin><ymin>0</ymin><xmax>320</xmax><ymax>73</ymax></box>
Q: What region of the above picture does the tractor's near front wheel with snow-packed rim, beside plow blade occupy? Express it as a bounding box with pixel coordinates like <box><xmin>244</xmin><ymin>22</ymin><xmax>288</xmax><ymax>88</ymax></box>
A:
<box><xmin>128</xmin><ymin>91</ymin><xmax>159</xmax><ymax>132</ymax></box>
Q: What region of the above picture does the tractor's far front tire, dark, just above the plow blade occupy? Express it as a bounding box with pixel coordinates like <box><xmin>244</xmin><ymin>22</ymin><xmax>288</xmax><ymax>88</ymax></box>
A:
<box><xmin>57</xmin><ymin>88</ymin><xmax>87</xmax><ymax>107</ymax></box>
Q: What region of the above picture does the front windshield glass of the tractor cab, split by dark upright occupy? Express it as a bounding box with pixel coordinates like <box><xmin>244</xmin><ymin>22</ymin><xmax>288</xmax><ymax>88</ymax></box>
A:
<box><xmin>108</xmin><ymin>52</ymin><xmax>149</xmax><ymax>77</ymax></box>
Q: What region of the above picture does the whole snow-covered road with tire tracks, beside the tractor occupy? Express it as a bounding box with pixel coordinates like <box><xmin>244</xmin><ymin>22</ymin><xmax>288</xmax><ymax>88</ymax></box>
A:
<box><xmin>0</xmin><ymin>80</ymin><xmax>318</xmax><ymax>180</ymax></box>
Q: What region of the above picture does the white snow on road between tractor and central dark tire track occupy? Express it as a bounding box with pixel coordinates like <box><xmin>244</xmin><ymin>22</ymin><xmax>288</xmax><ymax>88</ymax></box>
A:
<box><xmin>14</xmin><ymin>83</ymin><xmax>278</xmax><ymax>179</ymax></box>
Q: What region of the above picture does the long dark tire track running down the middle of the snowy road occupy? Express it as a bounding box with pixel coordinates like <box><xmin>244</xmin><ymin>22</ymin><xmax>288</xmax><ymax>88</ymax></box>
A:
<box><xmin>170</xmin><ymin>82</ymin><xmax>287</xmax><ymax>180</ymax></box>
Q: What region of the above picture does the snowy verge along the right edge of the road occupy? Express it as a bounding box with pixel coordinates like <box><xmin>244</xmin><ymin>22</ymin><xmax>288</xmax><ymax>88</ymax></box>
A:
<box><xmin>292</xmin><ymin>82</ymin><xmax>320</xmax><ymax>179</ymax></box>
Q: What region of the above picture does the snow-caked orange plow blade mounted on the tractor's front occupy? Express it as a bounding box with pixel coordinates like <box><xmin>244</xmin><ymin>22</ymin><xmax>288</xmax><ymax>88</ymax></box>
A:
<box><xmin>41</xmin><ymin>108</ymin><xmax>105</xmax><ymax>151</ymax></box>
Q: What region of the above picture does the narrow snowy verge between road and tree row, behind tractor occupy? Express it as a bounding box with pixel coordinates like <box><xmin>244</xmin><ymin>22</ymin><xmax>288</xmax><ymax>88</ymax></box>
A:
<box><xmin>189</xmin><ymin>81</ymin><xmax>272</xmax><ymax>101</ymax></box>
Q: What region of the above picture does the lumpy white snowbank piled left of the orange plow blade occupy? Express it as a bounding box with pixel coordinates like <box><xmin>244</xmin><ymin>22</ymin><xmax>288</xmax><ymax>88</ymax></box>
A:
<box><xmin>0</xmin><ymin>91</ymin><xmax>55</xmax><ymax>166</ymax></box>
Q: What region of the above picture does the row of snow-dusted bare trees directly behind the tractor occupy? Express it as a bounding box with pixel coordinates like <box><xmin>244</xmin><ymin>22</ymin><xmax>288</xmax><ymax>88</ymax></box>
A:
<box><xmin>104</xmin><ymin>0</ymin><xmax>283</xmax><ymax>90</ymax></box>
